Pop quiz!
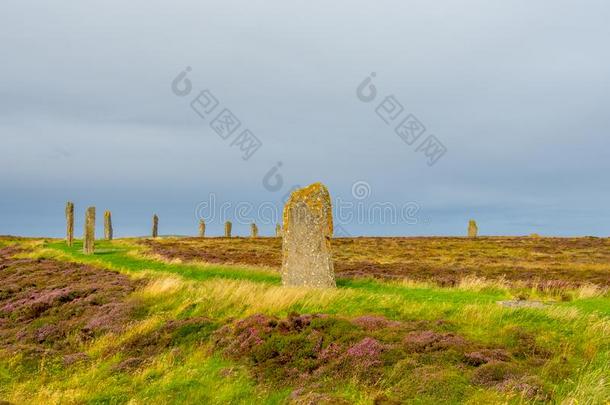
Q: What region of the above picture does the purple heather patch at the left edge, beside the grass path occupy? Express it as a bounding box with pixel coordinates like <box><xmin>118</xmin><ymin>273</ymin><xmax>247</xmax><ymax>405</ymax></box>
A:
<box><xmin>0</xmin><ymin>247</ymin><xmax>138</xmax><ymax>365</ymax></box>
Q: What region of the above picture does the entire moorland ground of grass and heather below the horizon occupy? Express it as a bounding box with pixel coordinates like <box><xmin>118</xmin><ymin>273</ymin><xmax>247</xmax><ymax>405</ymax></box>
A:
<box><xmin>0</xmin><ymin>238</ymin><xmax>610</xmax><ymax>404</ymax></box>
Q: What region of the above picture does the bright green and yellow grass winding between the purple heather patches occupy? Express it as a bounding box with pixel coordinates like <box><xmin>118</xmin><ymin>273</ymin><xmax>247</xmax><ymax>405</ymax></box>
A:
<box><xmin>0</xmin><ymin>240</ymin><xmax>610</xmax><ymax>404</ymax></box>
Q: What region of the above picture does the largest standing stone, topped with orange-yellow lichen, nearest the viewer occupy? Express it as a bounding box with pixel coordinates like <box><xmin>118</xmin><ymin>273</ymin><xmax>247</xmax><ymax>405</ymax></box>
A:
<box><xmin>281</xmin><ymin>183</ymin><xmax>336</xmax><ymax>287</ymax></box>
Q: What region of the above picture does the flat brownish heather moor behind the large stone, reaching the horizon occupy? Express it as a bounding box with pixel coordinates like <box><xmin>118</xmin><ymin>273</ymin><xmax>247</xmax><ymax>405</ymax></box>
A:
<box><xmin>142</xmin><ymin>237</ymin><xmax>610</xmax><ymax>288</ymax></box>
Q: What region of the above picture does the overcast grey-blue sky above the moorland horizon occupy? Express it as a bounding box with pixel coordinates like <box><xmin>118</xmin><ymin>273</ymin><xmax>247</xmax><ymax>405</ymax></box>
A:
<box><xmin>0</xmin><ymin>0</ymin><xmax>610</xmax><ymax>236</ymax></box>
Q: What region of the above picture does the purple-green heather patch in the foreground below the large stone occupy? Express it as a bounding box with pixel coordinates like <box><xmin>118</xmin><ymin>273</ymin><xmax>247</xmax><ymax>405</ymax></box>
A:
<box><xmin>212</xmin><ymin>313</ymin><xmax>546</xmax><ymax>402</ymax></box>
